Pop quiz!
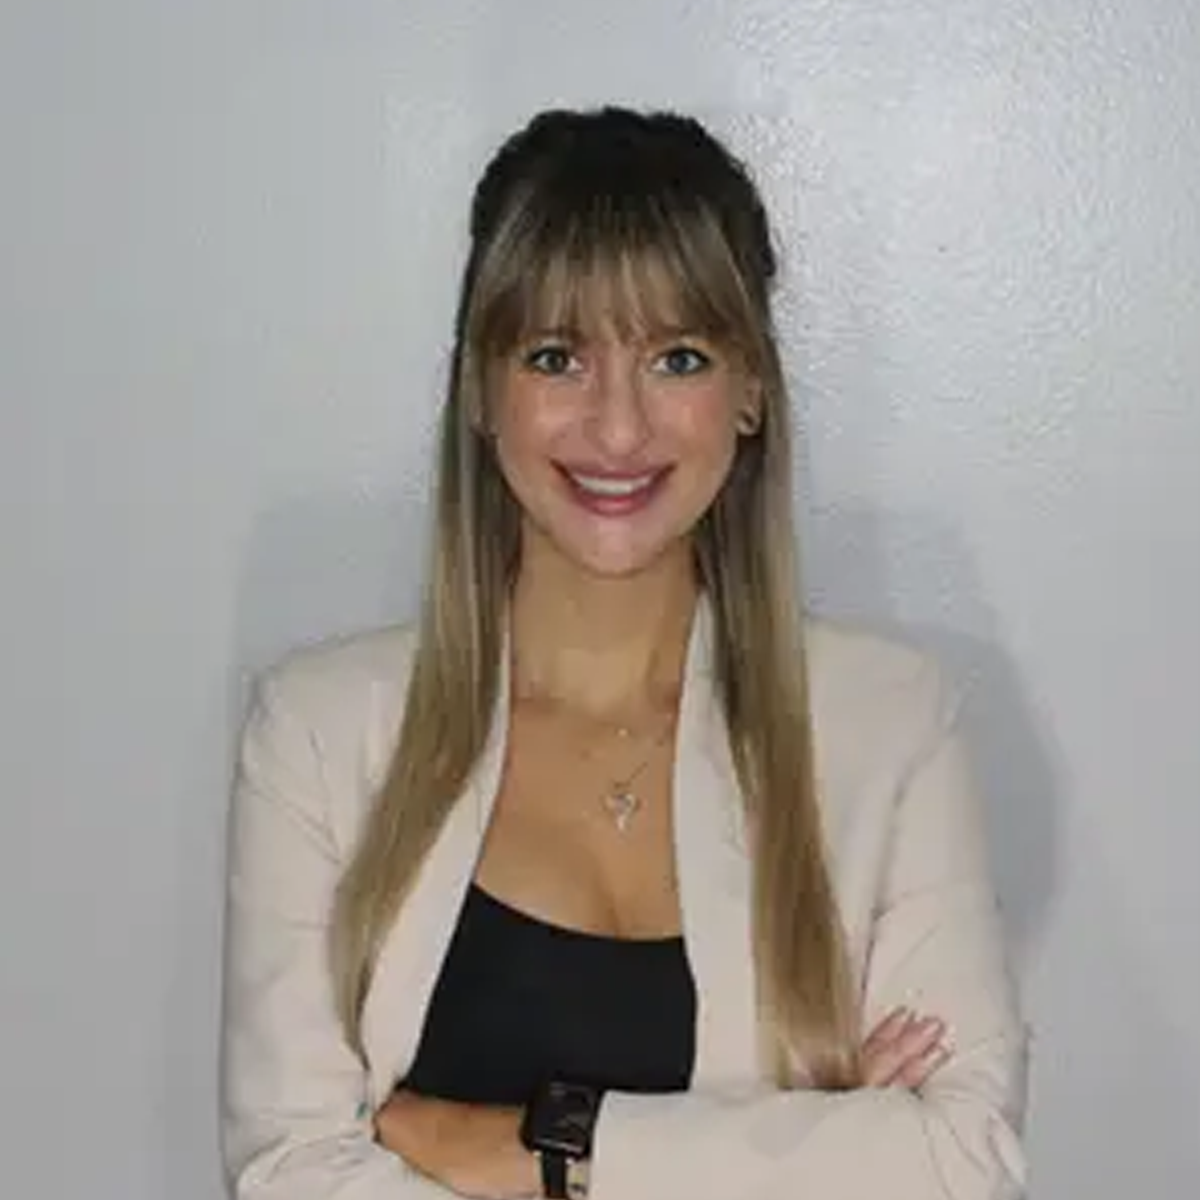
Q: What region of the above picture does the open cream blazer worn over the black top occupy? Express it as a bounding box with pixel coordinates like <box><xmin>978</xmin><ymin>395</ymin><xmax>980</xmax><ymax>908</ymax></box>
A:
<box><xmin>222</xmin><ymin>601</ymin><xmax>1027</xmax><ymax>1200</ymax></box>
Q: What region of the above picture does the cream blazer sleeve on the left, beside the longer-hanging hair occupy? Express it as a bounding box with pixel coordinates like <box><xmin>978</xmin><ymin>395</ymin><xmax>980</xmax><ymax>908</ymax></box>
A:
<box><xmin>221</xmin><ymin>668</ymin><xmax>452</xmax><ymax>1200</ymax></box>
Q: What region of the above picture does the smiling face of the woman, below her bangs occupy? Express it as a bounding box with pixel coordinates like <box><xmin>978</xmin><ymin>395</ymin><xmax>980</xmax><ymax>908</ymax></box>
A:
<box><xmin>488</xmin><ymin>307</ymin><xmax>757</xmax><ymax>577</ymax></box>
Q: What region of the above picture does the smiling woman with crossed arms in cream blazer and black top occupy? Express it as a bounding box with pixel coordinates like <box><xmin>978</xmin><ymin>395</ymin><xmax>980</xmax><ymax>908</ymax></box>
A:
<box><xmin>224</xmin><ymin>109</ymin><xmax>1025</xmax><ymax>1200</ymax></box>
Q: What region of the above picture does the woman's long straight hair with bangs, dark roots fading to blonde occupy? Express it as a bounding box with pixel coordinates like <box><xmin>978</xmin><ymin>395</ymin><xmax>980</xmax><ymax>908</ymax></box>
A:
<box><xmin>331</xmin><ymin>108</ymin><xmax>857</xmax><ymax>1087</ymax></box>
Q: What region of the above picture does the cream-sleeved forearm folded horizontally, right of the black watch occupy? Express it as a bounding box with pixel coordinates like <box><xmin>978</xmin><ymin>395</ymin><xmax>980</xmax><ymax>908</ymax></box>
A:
<box><xmin>592</xmin><ymin>1044</ymin><xmax>1025</xmax><ymax>1200</ymax></box>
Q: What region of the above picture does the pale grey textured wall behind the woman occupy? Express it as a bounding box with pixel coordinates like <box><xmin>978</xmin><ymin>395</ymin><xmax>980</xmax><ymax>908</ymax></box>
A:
<box><xmin>0</xmin><ymin>0</ymin><xmax>1200</xmax><ymax>1200</ymax></box>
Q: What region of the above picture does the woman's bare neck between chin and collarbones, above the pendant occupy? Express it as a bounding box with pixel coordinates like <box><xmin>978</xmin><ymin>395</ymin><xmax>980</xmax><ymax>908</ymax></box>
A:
<box><xmin>512</xmin><ymin>546</ymin><xmax>697</xmax><ymax>726</ymax></box>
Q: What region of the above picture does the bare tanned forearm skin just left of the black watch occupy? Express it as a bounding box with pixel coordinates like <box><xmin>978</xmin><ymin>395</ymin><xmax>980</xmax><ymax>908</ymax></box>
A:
<box><xmin>376</xmin><ymin>1088</ymin><xmax>541</xmax><ymax>1200</ymax></box>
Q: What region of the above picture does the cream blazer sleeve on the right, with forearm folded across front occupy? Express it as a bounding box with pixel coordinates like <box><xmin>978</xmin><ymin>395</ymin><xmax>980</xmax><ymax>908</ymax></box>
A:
<box><xmin>592</xmin><ymin>676</ymin><xmax>1027</xmax><ymax>1200</ymax></box>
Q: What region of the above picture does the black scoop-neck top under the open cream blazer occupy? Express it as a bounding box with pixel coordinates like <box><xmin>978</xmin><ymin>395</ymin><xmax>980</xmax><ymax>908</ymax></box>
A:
<box><xmin>404</xmin><ymin>883</ymin><xmax>696</xmax><ymax>1105</ymax></box>
